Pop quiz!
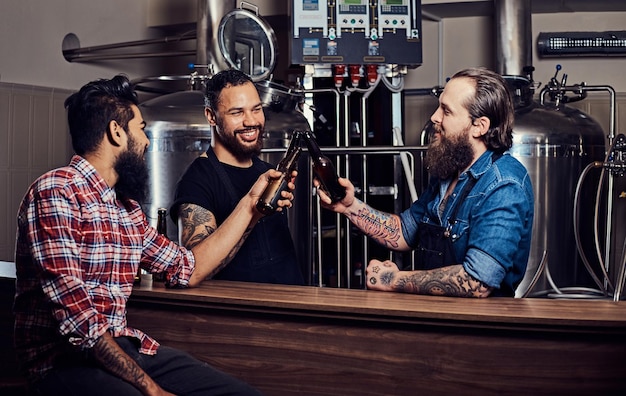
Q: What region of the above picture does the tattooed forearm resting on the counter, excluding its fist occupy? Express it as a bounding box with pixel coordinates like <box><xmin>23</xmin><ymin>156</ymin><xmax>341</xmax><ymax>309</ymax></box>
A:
<box><xmin>394</xmin><ymin>264</ymin><xmax>492</xmax><ymax>297</ymax></box>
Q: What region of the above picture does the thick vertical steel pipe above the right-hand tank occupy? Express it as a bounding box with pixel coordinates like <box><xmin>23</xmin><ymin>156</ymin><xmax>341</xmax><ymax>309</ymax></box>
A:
<box><xmin>494</xmin><ymin>0</ymin><xmax>532</xmax><ymax>76</ymax></box>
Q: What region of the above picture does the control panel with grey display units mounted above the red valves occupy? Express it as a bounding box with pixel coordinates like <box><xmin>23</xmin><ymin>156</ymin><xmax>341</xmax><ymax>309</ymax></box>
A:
<box><xmin>290</xmin><ymin>0</ymin><xmax>422</xmax><ymax>67</ymax></box>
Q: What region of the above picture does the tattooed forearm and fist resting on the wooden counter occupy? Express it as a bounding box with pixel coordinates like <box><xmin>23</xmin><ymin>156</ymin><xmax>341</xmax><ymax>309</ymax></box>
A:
<box><xmin>366</xmin><ymin>260</ymin><xmax>493</xmax><ymax>297</ymax></box>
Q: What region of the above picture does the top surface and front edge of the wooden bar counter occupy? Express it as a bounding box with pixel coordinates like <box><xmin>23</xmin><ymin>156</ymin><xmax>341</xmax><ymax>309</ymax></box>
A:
<box><xmin>131</xmin><ymin>280</ymin><xmax>626</xmax><ymax>335</ymax></box>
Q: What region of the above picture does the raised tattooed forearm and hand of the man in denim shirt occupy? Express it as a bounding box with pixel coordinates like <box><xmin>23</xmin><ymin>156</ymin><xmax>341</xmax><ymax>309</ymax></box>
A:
<box><xmin>315</xmin><ymin>177</ymin><xmax>411</xmax><ymax>251</ymax></box>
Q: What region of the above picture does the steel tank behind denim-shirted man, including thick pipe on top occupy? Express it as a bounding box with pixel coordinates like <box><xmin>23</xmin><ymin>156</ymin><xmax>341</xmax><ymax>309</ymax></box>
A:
<box><xmin>494</xmin><ymin>0</ymin><xmax>605</xmax><ymax>297</ymax></box>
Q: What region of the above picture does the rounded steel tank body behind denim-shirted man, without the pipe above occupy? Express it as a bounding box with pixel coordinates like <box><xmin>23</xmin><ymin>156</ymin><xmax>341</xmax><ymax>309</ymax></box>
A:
<box><xmin>511</xmin><ymin>101</ymin><xmax>605</xmax><ymax>297</ymax></box>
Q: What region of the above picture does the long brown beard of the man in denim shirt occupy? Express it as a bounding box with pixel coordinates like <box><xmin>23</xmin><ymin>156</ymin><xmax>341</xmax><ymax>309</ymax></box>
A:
<box><xmin>424</xmin><ymin>126</ymin><xmax>474</xmax><ymax>180</ymax></box>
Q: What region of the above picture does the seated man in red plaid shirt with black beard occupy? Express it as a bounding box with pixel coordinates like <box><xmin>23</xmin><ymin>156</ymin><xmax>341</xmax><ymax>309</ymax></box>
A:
<box><xmin>14</xmin><ymin>75</ymin><xmax>286</xmax><ymax>395</ymax></box>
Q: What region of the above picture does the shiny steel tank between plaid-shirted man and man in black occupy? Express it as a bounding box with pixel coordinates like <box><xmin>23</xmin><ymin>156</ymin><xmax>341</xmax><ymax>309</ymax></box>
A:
<box><xmin>139</xmin><ymin>91</ymin><xmax>211</xmax><ymax>241</ymax></box>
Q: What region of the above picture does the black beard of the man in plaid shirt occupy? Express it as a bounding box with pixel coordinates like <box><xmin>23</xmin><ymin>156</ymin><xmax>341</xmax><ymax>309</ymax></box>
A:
<box><xmin>114</xmin><ymin>141</ymin><xmax>149</xmax><ymax>203</ymax></box>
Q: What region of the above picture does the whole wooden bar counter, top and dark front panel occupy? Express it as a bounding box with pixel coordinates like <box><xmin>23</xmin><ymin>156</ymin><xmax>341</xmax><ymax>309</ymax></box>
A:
<box><xmin>128</xmin><ymin>281</ymin><xmax>626</xmax><ymax>396</ymax></box>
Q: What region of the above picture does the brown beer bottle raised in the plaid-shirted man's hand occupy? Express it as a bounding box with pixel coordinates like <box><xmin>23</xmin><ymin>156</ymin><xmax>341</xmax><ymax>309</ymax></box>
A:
<box><xmin>256</xmin><ymin>131</ymin><xmax>302</xmax><ymax>215</ymax></box>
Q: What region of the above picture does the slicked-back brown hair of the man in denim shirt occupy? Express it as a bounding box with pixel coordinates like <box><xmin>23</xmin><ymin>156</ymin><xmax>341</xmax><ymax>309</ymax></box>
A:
<box><xmin>452</xmin><ymin>67</ymin><xmax>515</xmax><ymax>153</ymax></box>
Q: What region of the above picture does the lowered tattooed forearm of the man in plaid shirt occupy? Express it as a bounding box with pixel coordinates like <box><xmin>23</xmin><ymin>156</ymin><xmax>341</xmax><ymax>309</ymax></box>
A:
<box><xmin>91</xmin><ymin>333</ymin><xmax>172</xmax><ymax>396</ymax></box>
